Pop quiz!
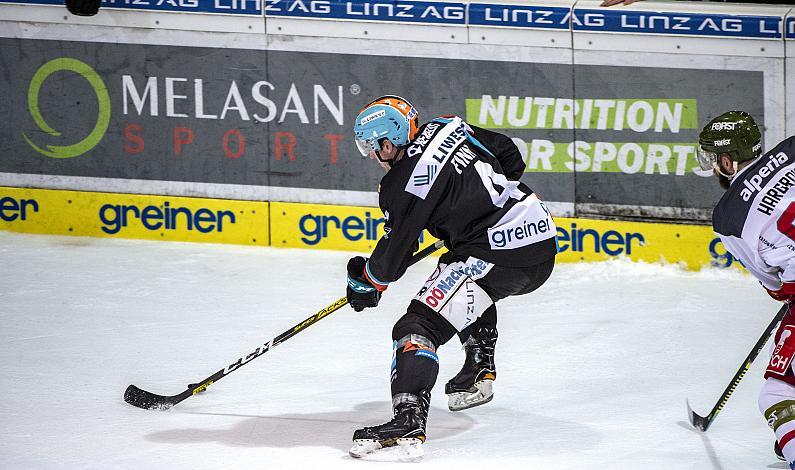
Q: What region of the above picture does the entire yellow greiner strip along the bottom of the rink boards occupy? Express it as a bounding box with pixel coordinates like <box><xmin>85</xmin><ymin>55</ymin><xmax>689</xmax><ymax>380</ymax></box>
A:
<box><xmin>0</xmin><ymin>187</ymin><xmax>737</xmax><ymax>269</ymax></box>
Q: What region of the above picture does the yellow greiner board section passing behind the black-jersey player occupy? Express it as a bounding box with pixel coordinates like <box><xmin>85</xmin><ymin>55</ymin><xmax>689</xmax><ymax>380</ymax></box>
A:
<box><xmin>271</xmin><ymin>202</ymin><xmax>739</xmax><ymax>269</ymax></box>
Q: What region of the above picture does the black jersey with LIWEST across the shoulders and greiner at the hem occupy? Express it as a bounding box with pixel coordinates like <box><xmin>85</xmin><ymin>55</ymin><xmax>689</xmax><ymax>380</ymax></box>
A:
<box><xmin>367</xmin><ymin>116</ymin><xmax>557</xmax><ymax>285</ymax></box>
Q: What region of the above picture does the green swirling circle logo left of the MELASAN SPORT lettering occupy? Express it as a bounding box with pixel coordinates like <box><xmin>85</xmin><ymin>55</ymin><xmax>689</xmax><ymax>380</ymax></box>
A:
<box><xmin>22</xmin><ymin>57</ymin><xmax>110</xmax><ymax>158</ymax></box>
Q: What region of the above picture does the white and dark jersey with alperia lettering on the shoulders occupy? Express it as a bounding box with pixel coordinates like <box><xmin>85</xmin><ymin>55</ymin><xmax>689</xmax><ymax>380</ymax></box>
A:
<box><xmin>712</xmin><ymin>136</ymin><xmax>795</xmax><ymax>290</ymax></box>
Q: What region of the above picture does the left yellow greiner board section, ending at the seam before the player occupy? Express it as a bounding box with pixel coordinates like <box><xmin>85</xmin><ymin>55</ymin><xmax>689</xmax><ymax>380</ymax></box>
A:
<box><xmin>0</xmin><ymin>187</ymin><xmax>270</xmax><ymax>246</ymax></box>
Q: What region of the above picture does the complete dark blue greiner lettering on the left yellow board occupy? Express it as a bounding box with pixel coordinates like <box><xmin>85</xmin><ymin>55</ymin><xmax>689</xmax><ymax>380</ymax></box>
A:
<box><xmin>99</xmin><ymin>201</ymin><xmax>235</xmax><ymax>235</ymax></box>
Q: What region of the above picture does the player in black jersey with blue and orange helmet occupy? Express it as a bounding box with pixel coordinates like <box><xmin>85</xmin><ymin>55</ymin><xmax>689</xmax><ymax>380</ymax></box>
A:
<box><xmin>347</xmin><ymin>96</ymin><xmax>557</xmax><ymax>457</ymax></box>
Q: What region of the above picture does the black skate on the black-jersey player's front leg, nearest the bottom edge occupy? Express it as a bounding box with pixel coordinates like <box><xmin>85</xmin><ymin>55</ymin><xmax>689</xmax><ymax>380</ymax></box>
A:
<box><xmin>350</xmin><ymin>390</ymin><xmax>431</xmax><ymax>461</ymax></box>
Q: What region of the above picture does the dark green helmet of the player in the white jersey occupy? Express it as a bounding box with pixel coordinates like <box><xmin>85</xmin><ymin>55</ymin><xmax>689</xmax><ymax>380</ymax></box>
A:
<box><xmin>696</xmin><ymin>111</ymin><xmax>762</xmax><ymax>179</ymax></box>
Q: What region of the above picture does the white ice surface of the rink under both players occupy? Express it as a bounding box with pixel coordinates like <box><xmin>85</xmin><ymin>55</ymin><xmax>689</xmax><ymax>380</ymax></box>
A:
<box><xmin>0</xmin><ymin>232</ymin><xmax>785</xmax><ymax>470</ymax></box>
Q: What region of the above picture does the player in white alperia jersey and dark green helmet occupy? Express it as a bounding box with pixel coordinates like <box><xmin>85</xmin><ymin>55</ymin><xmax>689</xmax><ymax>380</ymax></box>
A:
<box><xmin>698</xmin><ymin>111</ymin><xmax>795</xmax><ymax>462</ymax></box>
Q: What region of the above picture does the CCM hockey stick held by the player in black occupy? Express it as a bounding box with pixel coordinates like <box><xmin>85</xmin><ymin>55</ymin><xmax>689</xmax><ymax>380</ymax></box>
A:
<box><xmin>124</xmin><ymin>240</ymin><xmax>444</xmax><ymax>410</ymax></box>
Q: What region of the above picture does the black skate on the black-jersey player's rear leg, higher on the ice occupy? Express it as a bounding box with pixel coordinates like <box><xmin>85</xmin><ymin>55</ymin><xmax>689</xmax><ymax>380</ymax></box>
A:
<box><xmin>444</xmin><ymin>328</ymin><xmax>497</xmax><ymax>411</ymax></box>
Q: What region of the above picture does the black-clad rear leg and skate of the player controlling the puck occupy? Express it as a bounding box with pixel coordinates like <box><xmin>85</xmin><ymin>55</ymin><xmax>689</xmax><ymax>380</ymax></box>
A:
<box><xmin>445</xmin><ymin>260</ymin><xmax>554</xmax><ymax>411</ymax></box>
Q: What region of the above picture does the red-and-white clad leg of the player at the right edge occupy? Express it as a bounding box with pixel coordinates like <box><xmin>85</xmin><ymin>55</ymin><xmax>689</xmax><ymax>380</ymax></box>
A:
<box><xmin>759</xmin><ymin>311</ymin><xmax>795</xmax><ymax>467</ymax></box>
